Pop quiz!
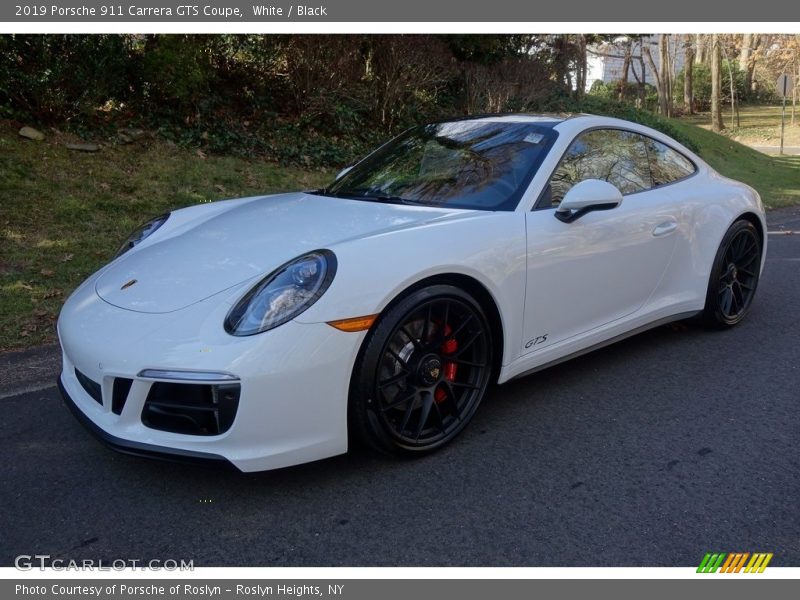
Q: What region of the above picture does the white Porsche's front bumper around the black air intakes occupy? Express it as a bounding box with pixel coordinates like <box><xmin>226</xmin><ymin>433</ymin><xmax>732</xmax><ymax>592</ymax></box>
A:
<box><xmin>58</xmin><ymin>274</ymin><xmax>364</xmax><ymax>471</ymax></box>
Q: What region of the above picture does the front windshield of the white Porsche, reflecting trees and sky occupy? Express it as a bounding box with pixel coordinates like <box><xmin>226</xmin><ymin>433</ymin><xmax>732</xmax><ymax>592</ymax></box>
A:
<box><xmin>318</xmin><ymin>121</ymin><xmax>557</xmax><ymax>210</ymax></box>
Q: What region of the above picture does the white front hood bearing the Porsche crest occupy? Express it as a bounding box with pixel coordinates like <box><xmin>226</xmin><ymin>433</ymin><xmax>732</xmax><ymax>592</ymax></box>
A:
<box><xmin>95</xmin><ymin>193</ymin><xmax>466</xmax><ymax>313</ymax></box>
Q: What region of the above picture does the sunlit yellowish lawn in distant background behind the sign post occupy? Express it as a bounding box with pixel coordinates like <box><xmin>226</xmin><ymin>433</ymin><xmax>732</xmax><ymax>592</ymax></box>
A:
<box><xmin>682</xmin><ymin>104</ymin><xmax>800</xmax><ymax>147</ymax></box>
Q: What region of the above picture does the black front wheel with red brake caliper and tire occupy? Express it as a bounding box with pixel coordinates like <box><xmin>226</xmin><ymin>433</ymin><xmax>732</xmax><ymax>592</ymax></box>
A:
<box><xmin>348</xmin><ymin>285</ymin><xmax>493</xmax><ymax>456</ymax></box>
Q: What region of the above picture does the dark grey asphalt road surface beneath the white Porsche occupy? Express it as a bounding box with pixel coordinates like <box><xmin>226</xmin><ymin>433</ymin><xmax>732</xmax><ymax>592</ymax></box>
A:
<box><xmin>0</xmin><ymin>211</ymin><xmax>800</xmax><ymax>566</ymax></box>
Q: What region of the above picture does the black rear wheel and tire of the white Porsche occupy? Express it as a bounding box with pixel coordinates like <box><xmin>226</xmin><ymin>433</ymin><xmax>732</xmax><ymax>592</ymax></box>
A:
<box><xmin>702</xmin><ymin>220</ymin><xmax>761</xmax><ymax>329</ymax></box>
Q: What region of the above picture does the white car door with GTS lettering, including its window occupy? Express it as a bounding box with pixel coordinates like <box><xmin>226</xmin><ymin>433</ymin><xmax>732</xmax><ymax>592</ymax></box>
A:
<box><xmin>522</xmin><ymin>128</ymin><xmax>680</xmax><ymax>354</ymax></box>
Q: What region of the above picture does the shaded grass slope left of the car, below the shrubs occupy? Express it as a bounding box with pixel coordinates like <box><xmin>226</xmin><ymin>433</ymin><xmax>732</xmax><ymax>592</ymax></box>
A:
<box><xmin>0</xmin><ymin>121</ymin><xmax>333</xmax><ymax>350</ymax></box>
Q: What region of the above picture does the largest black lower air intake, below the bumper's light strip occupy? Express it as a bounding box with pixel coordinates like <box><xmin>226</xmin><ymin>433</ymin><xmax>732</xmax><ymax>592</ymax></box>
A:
<box><xmin>142</xmin><ymin>381</ymin><xmax>241</xmax><ymax>435</ymax></box>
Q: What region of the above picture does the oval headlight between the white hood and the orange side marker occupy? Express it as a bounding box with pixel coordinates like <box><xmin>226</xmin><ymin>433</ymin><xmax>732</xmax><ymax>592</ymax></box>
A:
<box><xmin>225</xmin><ymin>250</ymin><xmax>336</xmax><ymax>336</ymax></box>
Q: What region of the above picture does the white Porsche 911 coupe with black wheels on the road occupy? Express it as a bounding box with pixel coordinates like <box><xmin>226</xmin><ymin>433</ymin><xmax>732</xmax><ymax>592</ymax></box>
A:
<box><xmin>58</xmin><ymin>115</ymin><xmax>766</xmax><ymax>471</ymax></box>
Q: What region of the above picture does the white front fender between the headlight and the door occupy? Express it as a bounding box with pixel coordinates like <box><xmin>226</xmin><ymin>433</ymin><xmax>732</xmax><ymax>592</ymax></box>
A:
<box><xmin>296</xmin><ymin>212</ymin><xmax>527</xmax><ymax>370</ymax></box>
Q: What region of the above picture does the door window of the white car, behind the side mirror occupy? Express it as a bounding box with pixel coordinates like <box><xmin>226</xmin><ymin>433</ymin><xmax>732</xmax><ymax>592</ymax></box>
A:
<box><xmin>545</xmin><ymin>129</ymin><xmax>653</xmax><ymax>206</ymax></box>
